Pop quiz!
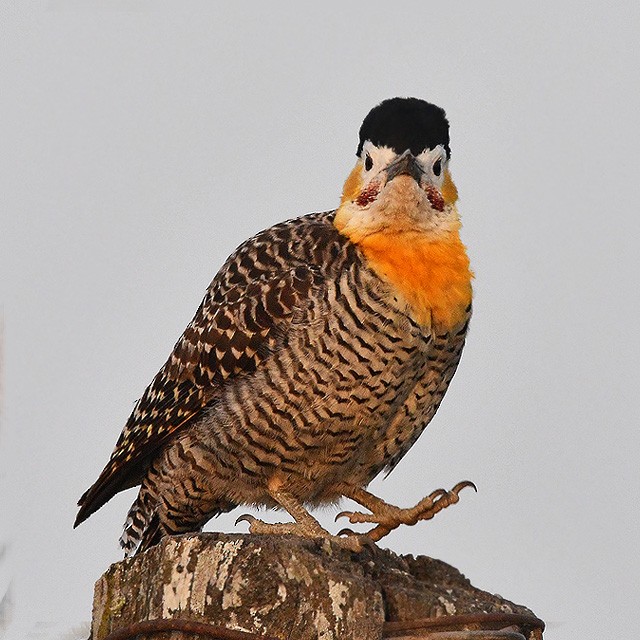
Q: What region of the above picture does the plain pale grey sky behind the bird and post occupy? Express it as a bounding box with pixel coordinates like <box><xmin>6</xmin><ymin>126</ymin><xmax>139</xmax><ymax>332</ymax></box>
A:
<box><xmin>0</xmin><ymin>0</ymin><xmax>640</xmax><ymax>640</ymax></box>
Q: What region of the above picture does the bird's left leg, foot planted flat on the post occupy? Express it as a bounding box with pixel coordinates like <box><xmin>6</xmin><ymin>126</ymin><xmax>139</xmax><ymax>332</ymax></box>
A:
<box><xmin>236</xmin><ymin>488</ymin><xmax>371</xmax><ymax>551</ymax></box>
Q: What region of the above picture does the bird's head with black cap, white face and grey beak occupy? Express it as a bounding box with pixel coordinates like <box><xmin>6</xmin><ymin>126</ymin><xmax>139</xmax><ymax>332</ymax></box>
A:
<box><xmin>335</xmin><ymin>98</ymin><xmax>459</xmax><ymax>242</ymax></box>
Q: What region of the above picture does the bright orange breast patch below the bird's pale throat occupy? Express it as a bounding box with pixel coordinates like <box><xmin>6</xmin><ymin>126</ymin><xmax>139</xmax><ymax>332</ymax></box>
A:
<box><xmin>358</xmin><ymin>231</ymin><xmax>473</xmax><ymax>332</ymax></box>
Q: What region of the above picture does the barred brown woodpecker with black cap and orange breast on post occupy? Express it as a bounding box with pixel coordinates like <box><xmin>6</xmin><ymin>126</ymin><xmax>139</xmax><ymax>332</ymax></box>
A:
<box><xmin>74</xmin><ymin>97</ymin><xmax>475</xmax><ymax>556</ymax></box>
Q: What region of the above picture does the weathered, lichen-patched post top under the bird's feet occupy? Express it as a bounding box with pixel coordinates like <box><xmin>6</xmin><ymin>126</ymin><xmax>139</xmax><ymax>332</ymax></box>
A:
<box><xmin>91</xmin><ymin>533</ymin><xmax>531</xmax><ymax>640</ymax></box>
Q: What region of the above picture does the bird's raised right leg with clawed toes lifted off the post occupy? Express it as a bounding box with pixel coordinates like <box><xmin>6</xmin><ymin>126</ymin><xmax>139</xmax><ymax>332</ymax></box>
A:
<box><xmin>336</xmin><ymin>480</ymin><xmax>476</xmax><ymax>541</ymax></box>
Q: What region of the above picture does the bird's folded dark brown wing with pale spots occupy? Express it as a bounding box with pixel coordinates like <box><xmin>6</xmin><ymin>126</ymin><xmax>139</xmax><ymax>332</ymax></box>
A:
<box><xmin>75</xmin><ymin>266</ymin><xmax>322</xmax><ymax>526</ymax></box>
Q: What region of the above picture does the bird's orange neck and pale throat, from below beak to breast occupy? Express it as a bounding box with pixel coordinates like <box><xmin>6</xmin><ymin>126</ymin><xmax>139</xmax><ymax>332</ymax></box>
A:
<box><xmin>334</xmin><ymin>165</ymin><xmax>473</xmax><ymax>332</ymax></box>
